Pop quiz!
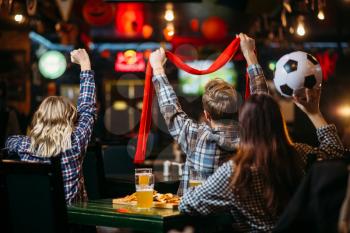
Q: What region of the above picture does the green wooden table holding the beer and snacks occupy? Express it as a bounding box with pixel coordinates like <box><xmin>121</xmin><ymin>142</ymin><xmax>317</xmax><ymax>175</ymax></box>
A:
<box><xmin>68</xmin><ymin>199</ymin><xmax>230</xmax><ymax>233</ymax></box>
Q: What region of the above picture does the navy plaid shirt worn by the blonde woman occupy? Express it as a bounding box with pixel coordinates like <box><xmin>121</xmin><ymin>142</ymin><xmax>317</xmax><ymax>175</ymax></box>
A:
<box><xmin>5</xmin><ymin>71</ymin><xmax>96</xmax><ymax>203</ymax></box>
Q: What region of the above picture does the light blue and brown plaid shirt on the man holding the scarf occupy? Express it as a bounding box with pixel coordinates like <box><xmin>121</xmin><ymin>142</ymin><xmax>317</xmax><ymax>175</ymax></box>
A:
<box><xmin>153</xmin><ymin>64</ymin><xmax>268</xmax><ymax>195</ymax></box>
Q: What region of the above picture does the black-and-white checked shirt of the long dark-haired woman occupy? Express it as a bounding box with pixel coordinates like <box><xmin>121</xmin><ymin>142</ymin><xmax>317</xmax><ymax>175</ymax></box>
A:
<box><xmin>179</xmin><ymin>125</ymin><xmax>344</xmax><ymax>232</ymax></box>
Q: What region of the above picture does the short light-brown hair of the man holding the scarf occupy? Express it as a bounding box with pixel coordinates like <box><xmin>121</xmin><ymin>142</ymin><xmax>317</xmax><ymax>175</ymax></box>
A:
<box><xmin>202</xmin><ymin>79</ymin><xmax>242</xmax><ymax>121</ymax></box>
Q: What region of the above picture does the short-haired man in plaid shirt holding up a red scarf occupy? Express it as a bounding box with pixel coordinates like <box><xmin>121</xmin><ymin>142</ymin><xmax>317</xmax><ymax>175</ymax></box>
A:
<box><xmin>150</xmin><ymin>33</ymin><xmax>268</xmax><ymax>195</ymax></box>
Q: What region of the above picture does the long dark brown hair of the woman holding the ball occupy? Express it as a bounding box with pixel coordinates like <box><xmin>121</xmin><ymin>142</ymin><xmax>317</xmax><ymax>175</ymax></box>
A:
<box><xmin>232</xmin><ymin>94</ymin><xmax>301</xmax><ymax>215</ymax></box>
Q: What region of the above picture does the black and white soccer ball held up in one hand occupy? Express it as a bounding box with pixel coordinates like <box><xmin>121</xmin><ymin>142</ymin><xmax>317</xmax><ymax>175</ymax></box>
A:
<box><xmin>273</xmin><ymin>51</ymin><xmax>322</xmax><ymax>97</ymax></box>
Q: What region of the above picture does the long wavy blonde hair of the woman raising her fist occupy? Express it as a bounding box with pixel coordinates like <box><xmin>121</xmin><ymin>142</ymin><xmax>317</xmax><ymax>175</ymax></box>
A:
<box><xmin>29</xmin><ymin>96</ymin><xmax>77</xmax><ymax>157</ymax></box>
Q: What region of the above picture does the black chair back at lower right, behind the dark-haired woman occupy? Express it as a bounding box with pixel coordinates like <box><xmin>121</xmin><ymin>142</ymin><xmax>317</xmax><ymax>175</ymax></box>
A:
<box><xmin>273</xmin><ymin>159</ymin><xmax>348</xmax><ymax>233</ymax></box>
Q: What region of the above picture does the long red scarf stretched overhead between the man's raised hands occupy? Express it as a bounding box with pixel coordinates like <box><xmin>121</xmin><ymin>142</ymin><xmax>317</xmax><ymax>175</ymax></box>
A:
<box><xmin>134</xmin><ymin>37</ymin><xmax>249</xmax><ymax>164</ymax></box>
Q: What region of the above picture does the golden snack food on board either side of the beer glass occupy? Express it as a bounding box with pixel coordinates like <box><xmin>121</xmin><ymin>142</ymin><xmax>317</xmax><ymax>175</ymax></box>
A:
<box><xmin>113</xmin><ymin>191</ymin><xmax>181</xmax><ymax>209</ymax></box>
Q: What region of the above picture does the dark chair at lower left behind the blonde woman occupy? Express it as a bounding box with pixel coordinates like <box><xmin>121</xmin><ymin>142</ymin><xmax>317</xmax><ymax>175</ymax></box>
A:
<box><xmin>0</xmin><ymin>157</ymin><xmax>68</xmax><ymax>233</ymax></box>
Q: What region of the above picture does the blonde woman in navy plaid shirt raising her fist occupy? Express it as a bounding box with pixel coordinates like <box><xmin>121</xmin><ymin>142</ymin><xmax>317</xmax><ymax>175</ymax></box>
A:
<box><xmin>5</xmin><ymin>49</ymin><xmax>96</xmax><ymax>203</ymax></box>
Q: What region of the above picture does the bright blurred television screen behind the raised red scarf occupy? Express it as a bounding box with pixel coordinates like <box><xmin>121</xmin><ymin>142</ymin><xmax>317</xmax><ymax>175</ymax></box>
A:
<box><xmin>179</xmin><ymin>60</ymin><xmax>237</xmax><ymax>95</ymax></box>
